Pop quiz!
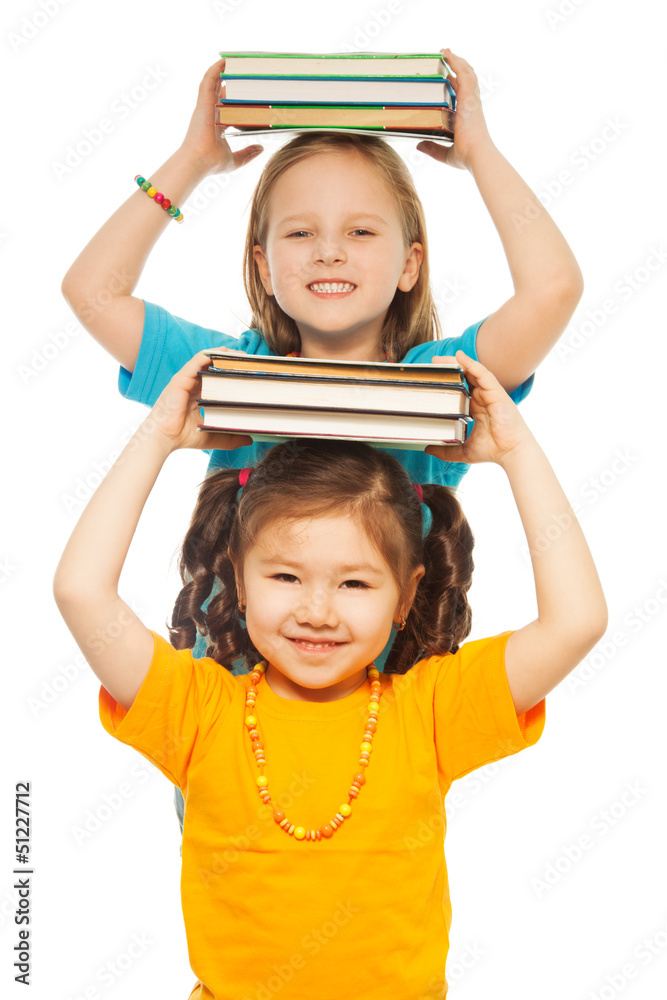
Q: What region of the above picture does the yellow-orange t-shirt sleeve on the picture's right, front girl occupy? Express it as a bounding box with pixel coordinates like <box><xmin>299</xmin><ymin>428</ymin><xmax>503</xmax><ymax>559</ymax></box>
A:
<box><xmin>433</xmin><ymin>632</ymin><xmax>545</xmax><ymax>782</ymax></box>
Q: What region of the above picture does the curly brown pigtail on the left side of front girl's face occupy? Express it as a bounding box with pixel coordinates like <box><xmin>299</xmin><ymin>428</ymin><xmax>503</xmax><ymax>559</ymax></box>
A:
<box><xmin>169</xmin><ymin>469</ymin><xmax>261</xmax><ymax>670</ymax></box>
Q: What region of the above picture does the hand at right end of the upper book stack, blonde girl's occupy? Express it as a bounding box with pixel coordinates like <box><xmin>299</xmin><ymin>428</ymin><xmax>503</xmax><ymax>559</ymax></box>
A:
<box><xmin>417</xmin><ymin>49</ymin><xmax>492</xmax><ymax>170</ymax></box>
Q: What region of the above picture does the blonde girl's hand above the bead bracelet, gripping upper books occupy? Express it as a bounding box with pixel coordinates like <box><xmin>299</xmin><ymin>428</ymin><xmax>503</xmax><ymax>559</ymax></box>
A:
<box><xmin>181</xmin><ymin>59</ymin><xmax>264</xmax><ymax>174</ymax></box>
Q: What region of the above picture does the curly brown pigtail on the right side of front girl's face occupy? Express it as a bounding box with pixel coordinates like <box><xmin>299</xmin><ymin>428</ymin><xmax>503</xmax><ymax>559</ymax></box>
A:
<box><xmin>384</xmin><ymin>484</ymin><xmax>474</xmax><ymax>674</ymax></box>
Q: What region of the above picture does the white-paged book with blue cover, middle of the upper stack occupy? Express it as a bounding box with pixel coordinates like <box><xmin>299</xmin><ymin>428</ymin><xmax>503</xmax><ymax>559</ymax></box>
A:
<box><xmin>220</xmin><ymin>73</ymin><xmax>452</xmax><ymax>108</ymax></box>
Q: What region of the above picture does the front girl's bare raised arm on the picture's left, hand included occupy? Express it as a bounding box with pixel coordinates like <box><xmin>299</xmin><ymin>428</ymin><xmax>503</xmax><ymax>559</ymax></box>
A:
<box><xmin>53</xmin><ymin>354</ymin><xmax>251</xmax><ymax>709</ymax></box>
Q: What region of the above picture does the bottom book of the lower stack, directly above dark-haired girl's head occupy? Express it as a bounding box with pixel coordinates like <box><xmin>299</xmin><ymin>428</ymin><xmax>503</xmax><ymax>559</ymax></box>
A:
<box><xmin>199</xmin><ymin>403</ymin><xmax>470</xmax><ymax>451</ymax></box>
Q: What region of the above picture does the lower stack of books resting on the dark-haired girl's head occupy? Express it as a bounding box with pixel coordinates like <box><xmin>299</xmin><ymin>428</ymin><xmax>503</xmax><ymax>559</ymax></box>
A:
<box><xmin>199</xmin><ymin>351</ymin><xmax>471</xmax><ymax>450</ymax></box>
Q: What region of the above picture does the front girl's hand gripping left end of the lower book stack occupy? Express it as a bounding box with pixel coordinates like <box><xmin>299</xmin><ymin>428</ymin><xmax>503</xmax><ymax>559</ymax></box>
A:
<box><xmin>143</xmin><ymin>351</ymin><xmax>252</xmax><ymax>451</ymax></box>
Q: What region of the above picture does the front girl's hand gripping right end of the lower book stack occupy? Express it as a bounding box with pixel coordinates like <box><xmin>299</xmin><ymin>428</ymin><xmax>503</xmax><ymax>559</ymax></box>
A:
<box><xmin>426</xmin><ymin>351</ymin><xmax>535</xmax><ymax>465</ymax></box>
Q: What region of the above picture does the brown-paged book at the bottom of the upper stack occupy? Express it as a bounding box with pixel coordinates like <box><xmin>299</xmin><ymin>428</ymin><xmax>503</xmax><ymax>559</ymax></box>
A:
<box><xmin>216</xmin><ymin>101</ymin><xmax>454</xmax><ymax>138</ymax></box>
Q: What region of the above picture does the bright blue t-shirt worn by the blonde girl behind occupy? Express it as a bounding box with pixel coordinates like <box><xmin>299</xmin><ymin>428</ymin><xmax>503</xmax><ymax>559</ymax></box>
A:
<box><xmin>118</xmin><ymin>302</ymin><xmax>534</xmax><ymax>488</ymax></box>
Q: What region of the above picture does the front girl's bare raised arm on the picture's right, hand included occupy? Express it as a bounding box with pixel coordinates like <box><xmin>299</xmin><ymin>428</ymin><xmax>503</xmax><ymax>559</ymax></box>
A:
<box><xmin>427</xmin><ymin>351</ymin><xmax>607</xmax><ymax>715</ymax></box>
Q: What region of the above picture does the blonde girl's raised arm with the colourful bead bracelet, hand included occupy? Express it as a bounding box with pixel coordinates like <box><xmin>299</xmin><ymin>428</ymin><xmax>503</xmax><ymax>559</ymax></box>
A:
<box><xmin>62</xmin><ymin>59</ymin><xmax>262</xmax><ymax>371</ymax></box>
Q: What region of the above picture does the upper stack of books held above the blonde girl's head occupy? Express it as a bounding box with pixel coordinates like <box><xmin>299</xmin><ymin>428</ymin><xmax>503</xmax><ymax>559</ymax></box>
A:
<box><xmin>216</xmin><ymin>52</ymin><xmax>456</xmax><ymax>142</ymax></box>
